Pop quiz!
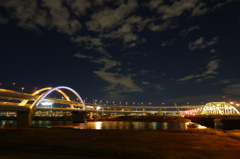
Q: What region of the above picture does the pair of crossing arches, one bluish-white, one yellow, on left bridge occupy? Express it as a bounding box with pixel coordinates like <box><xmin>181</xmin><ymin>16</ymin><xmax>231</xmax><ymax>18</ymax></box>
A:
<box><xmin>31</xmin><ymin>86</ymin><xmax>86</xmax><ymax>110</ymax></box>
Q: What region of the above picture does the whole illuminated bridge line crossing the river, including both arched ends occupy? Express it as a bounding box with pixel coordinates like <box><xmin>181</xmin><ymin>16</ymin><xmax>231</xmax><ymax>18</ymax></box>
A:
<box><xmin>0</xmin><ymin>86</ymin><xmax>240</xmax><ymax>125</ymax></box>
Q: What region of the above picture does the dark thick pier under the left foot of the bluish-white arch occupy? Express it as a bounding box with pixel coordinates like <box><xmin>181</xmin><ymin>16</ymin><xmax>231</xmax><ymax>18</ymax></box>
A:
<box><xmin>17</xmin><ymin>110</ymin><xmax>35</xmax><ymax>127</ymax></box>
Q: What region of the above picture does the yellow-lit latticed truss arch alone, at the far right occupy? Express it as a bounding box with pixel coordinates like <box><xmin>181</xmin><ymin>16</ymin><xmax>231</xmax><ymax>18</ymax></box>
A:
<box><xmin>201</xmin><ymin>102</ymin><xmax>240</xmax><ymax>115</ymax></box>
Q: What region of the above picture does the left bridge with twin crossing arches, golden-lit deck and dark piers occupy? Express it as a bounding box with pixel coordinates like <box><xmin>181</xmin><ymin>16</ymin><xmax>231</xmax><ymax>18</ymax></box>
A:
<box><xmin>0</xmin><ymin>86</ymin><xmax>87</xmax><ymax>126</ymax></box>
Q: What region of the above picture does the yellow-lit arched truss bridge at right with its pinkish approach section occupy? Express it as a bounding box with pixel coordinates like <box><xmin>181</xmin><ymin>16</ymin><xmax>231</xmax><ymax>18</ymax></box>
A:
<box><xmin>184</xmin><ymin>102</ymin><xmax>240</xmax><ymax>115</ymax></box>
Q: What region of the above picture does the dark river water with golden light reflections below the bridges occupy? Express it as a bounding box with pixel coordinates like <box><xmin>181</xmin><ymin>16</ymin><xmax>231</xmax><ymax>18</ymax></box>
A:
<box><xmin>0</xmin><ymin>120</ymin><xmax>222</xmax><ymax>130</ymax></box>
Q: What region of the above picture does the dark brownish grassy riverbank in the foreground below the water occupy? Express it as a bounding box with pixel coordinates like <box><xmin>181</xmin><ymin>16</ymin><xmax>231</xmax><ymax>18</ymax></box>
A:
<box><xmin>0</xmin><ymin>128</ymin><xmax>240</xmax><ymax>159</ymax></box>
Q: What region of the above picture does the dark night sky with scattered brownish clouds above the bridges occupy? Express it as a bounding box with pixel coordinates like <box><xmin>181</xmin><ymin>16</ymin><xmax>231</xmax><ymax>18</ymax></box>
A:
<box><xmin>0</xmin><ymin>0</ymin><xmax>240</xmax><ymax>105</ymax></box>
